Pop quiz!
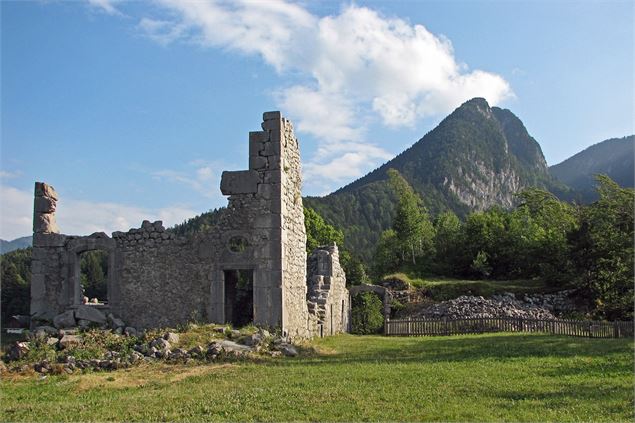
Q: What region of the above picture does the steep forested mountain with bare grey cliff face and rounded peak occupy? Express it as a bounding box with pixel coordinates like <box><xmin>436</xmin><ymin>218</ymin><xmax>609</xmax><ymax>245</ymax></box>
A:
<box><xmin>304</xmin><ymin>98</ymin><xmax>566</xmax><ymax>259</ymax></box>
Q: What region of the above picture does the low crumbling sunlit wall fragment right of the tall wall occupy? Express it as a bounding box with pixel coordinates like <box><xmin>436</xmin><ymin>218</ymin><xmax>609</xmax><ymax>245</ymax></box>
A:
<box><xmin>307</xmin><ymin>245</ymin><xmax>350</xmax><ymax>336</ymax></box>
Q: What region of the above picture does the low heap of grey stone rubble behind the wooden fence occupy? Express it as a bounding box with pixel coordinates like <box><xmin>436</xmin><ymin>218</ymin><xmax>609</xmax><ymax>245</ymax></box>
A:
<box><xmin>417</xmin><ymin>294</ymin><xmax>555</xmax><ymax>319</ymax></box>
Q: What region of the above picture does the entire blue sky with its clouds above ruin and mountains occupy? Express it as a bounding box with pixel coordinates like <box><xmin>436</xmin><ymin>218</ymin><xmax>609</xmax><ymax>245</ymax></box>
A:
<box><xmin>0</xmin><ymin>0</ymin><xmax>635</xmax><ymax>239</ymax></box>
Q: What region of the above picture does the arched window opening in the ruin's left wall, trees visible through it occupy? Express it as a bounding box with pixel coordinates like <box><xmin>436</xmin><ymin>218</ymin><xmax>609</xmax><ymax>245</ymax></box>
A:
<box><xmin>79</xmin><ymin>250</ymin><xmax>108</xmax><ymax>304</ymax></box>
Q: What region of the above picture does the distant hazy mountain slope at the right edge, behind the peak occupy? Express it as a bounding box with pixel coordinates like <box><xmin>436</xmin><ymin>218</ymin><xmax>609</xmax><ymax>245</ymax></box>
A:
<box><xmin>549</xmin><ymin>135</ymin><xmax>635</xmax><ymax>202</ymax></box>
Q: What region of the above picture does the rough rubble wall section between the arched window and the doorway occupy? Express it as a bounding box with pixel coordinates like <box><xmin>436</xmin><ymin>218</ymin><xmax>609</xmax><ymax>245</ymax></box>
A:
<box><xmin>110</xmin><ymin>221</ymin><xmax>209</xmax><ymax>328</ymax></box>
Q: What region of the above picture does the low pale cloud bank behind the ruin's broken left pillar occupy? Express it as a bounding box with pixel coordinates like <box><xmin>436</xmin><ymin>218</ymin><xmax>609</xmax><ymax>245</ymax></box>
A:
<box><xmin>0</xmin><ymin>185</ymin><xmax>199</xmax><ymax>240</ymax></box>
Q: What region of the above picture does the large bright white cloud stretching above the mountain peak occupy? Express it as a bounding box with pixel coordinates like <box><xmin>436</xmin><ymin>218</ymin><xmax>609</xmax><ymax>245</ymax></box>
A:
<box><xmin>139</xmin><ymin>0</ymin><xmax>513</xmax><ymax>190</ymax></box>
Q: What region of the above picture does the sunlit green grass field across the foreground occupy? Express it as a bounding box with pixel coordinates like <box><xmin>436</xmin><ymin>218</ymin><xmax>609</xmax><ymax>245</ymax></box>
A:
<box><xmin>0</xmin><ymin>334</ymin><xmax>635</xmax><ymax>422</ymax></box>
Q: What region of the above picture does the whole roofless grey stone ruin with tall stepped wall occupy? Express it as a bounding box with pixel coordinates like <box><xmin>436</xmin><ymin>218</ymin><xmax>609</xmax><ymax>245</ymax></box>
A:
<box><xmin>31</xmin><ymin>112</ymin><xmax>350</xmax><ymax>338</ymax></box>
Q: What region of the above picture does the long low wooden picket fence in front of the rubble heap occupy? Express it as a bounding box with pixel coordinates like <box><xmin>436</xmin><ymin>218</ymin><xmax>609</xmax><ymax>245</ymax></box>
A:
<box><xmin>384</xmin><ymin>317</ymin><xmax>635</xmax><ymax>338</ymax></box>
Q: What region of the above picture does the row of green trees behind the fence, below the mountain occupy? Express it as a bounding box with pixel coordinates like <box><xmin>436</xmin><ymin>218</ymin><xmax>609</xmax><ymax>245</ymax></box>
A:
<box><xmin>370</xmin><ymin>170</ymin><xmax>635</xmax><ymax>320</ymax></box>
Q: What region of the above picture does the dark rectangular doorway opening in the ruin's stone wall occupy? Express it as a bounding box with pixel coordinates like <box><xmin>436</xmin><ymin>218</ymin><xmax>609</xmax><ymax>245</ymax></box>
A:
<box><xmin>225</xmin><ymin>269</ymin><xmax>254</xmax><ymax>327</ymax></box>
